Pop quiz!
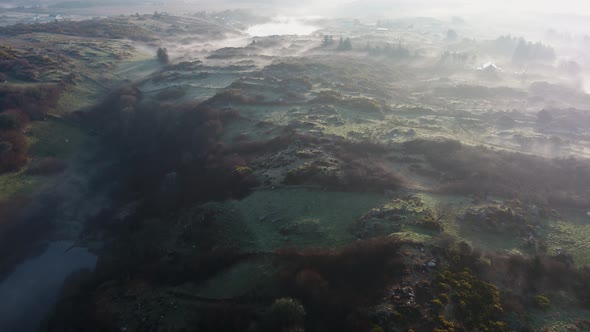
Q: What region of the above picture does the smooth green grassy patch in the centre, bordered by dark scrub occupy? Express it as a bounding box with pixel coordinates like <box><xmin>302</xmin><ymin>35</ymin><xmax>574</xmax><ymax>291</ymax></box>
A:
<box><xmin>210</xmin><ymin>188</ymin><xmax>384</xmax><ymax>252</ymax></box>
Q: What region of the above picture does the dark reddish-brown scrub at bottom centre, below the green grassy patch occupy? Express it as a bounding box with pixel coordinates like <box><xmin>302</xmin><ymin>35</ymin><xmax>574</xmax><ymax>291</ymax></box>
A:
<box><xmin>276</xmin><ymin>237</ymin><xmax>403</xmax><ymax>331</ymax></box>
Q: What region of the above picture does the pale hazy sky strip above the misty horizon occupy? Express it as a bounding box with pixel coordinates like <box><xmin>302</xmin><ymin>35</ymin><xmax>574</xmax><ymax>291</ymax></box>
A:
<box><xmin>0</xmin><ymin>0</ymin><xmax>590</xmax><ymax>26</ymax></box>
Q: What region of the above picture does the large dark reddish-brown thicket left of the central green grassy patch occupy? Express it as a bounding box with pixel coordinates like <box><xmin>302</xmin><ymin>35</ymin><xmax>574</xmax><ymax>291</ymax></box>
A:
<box><xmin>89</xmin><ymin>85</ymin><xmax>257</xmax><ymax>212</ymax></box>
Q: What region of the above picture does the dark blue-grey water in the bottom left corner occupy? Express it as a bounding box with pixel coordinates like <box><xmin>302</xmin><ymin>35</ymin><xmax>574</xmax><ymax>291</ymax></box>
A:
<box><xmin>0</xmin><ymin>242</ymin><xmax>96</xmax><ymax>332</ymax></box>
